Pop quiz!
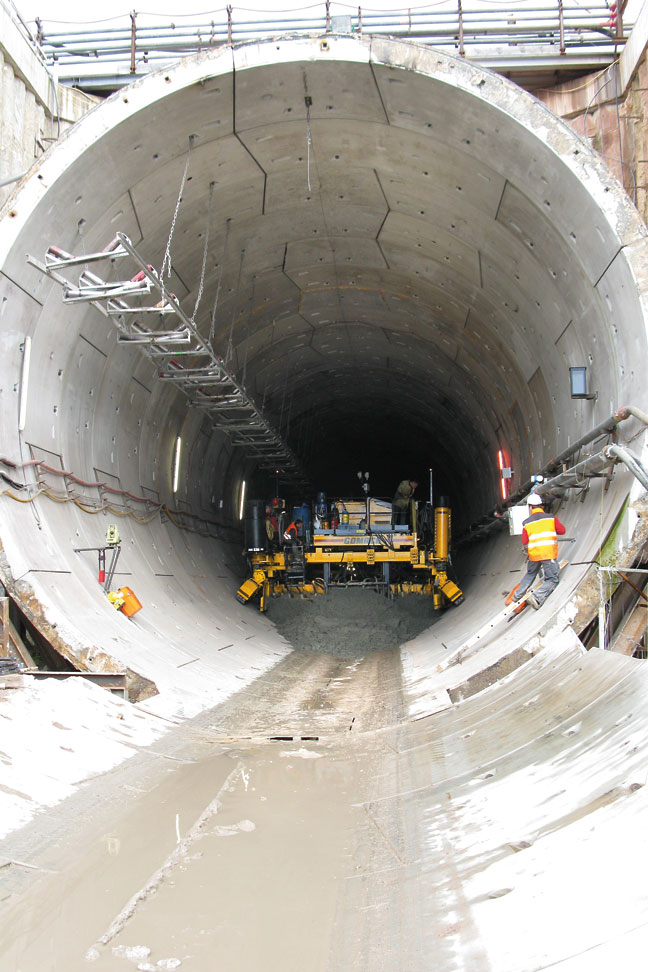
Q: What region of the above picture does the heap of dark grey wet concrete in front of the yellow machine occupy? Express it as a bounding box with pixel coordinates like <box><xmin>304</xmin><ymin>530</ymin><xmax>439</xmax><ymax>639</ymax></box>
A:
<box><xmin>268</xmin><ymin>587</ymin><xmax>436</xmax><ymax>658</ymax></box>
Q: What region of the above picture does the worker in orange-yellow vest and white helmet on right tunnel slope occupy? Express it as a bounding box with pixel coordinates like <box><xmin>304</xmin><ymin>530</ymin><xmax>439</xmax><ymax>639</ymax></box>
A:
<box><xmin>513</xmin><ymin>493</ymin><xmax>565</xmax><ymax>611</ymax></box>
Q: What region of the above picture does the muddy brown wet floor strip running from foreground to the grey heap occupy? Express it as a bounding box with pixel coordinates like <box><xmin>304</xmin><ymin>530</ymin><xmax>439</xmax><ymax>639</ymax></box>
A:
<box><xmin>0</xmin><ymin>624</ymin><xmax>416</xmax><ymax>972</ymax></box>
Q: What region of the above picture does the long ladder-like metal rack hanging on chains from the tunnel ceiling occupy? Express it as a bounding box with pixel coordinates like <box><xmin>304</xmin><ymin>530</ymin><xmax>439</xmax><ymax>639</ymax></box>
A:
<box><xmin>27</xmin><ymin>233</ymin><xmax>307</xmax><ymax>483</ymax></box>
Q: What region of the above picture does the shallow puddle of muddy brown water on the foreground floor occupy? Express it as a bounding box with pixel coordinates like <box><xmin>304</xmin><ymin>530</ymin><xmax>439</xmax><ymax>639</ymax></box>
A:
<box><xmin>93</xmin><ymin>746</ymin><xmax>358</xmax><ymax>972</ymax></box>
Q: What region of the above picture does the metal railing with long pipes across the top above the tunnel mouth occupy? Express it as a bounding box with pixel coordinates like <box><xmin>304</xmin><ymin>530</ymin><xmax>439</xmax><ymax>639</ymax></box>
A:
<box><xmin>29</xmin><ymin>0</ymin><xmax>629</xmax><ymax>83</ymax></box>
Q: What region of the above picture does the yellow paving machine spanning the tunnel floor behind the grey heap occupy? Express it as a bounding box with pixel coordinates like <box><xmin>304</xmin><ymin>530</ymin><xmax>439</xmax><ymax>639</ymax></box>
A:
<box><xmin>236</xmin><ymin>493</ymin><xmax>463</xmax><ymax>611</ymax></box>
